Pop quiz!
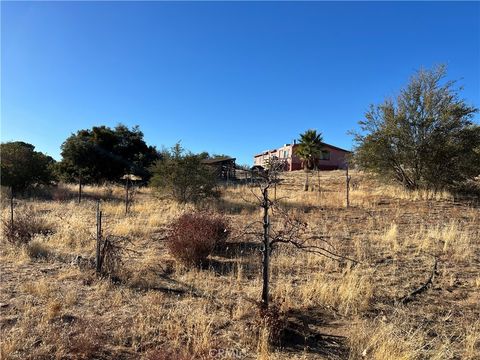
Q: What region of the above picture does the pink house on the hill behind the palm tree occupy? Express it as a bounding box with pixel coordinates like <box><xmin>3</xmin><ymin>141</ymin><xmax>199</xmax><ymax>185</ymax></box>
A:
<box><xmin>253</xmin><ymin>141</ymin><xmax>350</xmax><ymax>171</ymax></box>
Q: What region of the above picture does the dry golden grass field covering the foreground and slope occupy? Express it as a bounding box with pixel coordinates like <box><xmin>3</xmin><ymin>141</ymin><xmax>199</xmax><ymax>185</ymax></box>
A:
<box><xmin>0</xmin><ymin>171</ymin><xmax>480</xmax><ymax>360</ymax></box>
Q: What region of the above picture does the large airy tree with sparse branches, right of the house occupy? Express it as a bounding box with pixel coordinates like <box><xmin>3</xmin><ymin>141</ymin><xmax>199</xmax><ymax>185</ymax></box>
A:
<box><xmin>355</xmin><ymin>65</ymin><xmax>480</xmax><ymax>191</ymax></box>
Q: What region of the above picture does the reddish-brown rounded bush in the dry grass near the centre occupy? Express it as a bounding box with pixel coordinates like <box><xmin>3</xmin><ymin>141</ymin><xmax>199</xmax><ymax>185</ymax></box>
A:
<box><xmin>167</xmin><ymin>213</ymin><xmax>228</xmax><ymax>266</ymax></box>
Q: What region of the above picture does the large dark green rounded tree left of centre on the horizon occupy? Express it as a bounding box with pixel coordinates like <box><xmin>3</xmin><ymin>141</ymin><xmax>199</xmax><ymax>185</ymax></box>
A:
<box><xmin>59</xmin><ymin>124</ymin><xmax>159</xmax><ymax>183</ymax></box>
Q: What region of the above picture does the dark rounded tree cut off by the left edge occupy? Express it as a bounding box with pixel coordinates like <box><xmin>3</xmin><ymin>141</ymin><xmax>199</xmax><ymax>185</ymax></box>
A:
<box><xmin>0</xmin><ymin>141</ymin><xmax>55</xmax><ymax>194</ymax></box>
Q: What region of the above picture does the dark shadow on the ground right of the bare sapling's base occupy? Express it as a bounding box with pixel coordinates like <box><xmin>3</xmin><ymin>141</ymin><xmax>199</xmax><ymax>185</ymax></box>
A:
<box><xmin>281</xmin><ymin>310</ymin><xmax>350</xmax><ymax>359</ymax></box>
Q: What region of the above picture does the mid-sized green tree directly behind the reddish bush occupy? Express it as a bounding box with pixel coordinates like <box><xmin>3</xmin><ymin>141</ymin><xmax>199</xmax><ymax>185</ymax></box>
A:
<box><xmin>150</xmin><ymin>143</ymin><xmax>217</xmax><ymax>203</ymax></box>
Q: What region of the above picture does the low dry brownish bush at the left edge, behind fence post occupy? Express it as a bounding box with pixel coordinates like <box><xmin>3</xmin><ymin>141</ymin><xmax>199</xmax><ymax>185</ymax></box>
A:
<box><xmin>2</xmin><ymin>209</ymin><xmax>53</xmax><ymax>245</ymax></box>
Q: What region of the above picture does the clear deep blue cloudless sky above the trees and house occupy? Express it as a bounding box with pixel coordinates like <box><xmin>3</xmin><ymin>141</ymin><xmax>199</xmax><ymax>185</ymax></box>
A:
<box><xmin>1</xmin><ymin>1</ymin><xmax>480</xmax><ymax>163</ymax></box>
